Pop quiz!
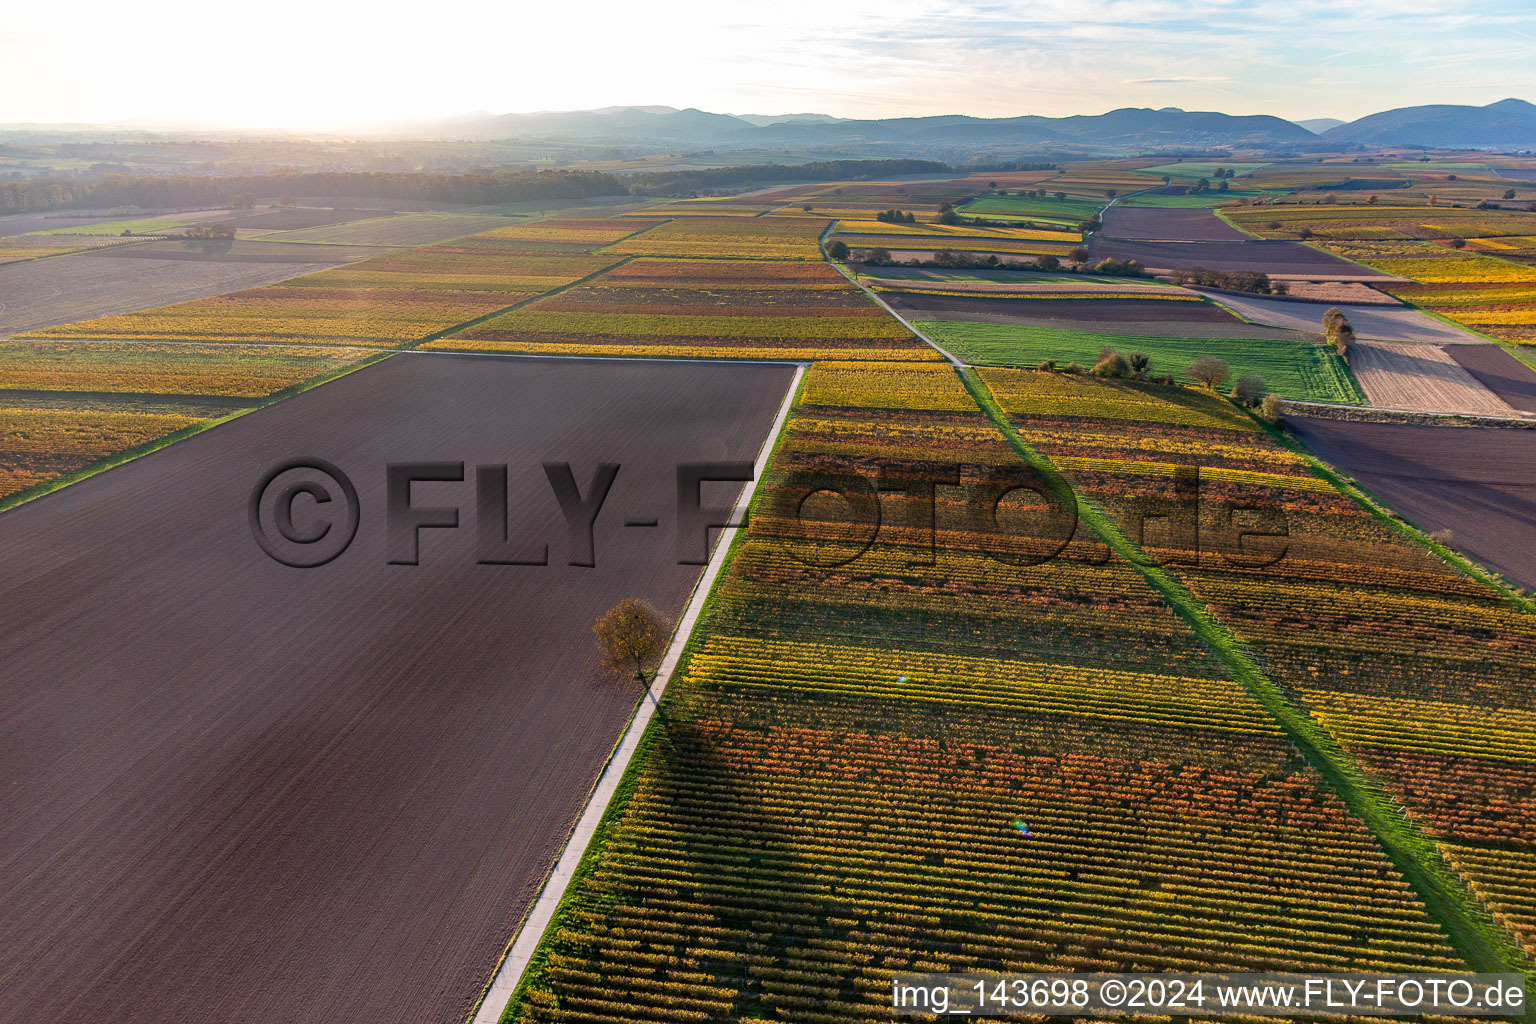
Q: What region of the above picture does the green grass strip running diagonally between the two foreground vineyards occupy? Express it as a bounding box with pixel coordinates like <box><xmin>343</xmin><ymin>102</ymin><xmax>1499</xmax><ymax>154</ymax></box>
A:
<box><xmin>955</xmin><ymin>367</ymin><xmax>1536</xmax><ymax>1021</ymax></box>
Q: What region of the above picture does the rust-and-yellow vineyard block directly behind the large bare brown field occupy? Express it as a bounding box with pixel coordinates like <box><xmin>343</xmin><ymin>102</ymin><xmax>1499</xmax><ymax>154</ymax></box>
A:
<box><xmin>427</xmin><ymin>259</ymin><xmax>938</xmax><ymax>359</ymax></box>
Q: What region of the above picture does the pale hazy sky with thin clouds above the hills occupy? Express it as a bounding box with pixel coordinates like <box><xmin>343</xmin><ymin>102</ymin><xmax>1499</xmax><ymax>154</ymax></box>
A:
<box><xmin>0</xmin><ymin>0</ymin><xmax>1536</xmax><ymax>130</ymax></box>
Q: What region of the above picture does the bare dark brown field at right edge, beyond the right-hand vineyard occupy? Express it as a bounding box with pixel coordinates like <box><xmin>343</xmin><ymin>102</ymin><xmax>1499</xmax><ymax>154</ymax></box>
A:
<box><xmin>1286</xmin><ymin>413</ymin><xmax>1536</xmax><ymax>586</ymax></box>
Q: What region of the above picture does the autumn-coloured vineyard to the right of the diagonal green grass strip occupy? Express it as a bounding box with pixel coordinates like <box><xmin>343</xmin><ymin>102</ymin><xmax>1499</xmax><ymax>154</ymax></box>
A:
<box><xmin>982</xmin><ymin>370</ymin><xmax>1536</xmax><ymax>953</ymax></box>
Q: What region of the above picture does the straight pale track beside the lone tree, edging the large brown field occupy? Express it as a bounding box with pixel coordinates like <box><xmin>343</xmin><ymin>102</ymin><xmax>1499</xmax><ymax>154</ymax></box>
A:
<box><xmin>470</xmin><ymin>362</ymin><xmax>806</xmax><ymax>1024</ymax></box>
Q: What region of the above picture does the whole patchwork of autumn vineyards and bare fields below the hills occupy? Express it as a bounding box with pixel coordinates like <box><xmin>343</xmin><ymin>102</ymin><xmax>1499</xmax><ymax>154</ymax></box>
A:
<box><xmin>9</xmin><ymin>151</ymin><xmax>1536</xmax><ymax>1024</ymax></box>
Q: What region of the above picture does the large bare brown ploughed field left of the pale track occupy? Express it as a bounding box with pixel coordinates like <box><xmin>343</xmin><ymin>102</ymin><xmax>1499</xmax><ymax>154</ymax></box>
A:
<box><xmin>0</xmin><ymin>355</ymin><xmax>791</xmax><ymax>1024</ymax></box>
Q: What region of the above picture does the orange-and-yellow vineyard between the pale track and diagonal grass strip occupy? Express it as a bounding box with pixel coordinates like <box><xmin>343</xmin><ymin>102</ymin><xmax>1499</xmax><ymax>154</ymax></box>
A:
<box><xmin>497</xmin><ymin>364</ymin><xmax>1459</xmax><ymax>1021</ymax></box>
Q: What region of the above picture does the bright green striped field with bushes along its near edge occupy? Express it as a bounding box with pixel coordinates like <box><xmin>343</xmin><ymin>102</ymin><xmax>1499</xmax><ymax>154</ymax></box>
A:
<box><xmin>915</xmin><ymin>321</ymin><xmax>1366</xmax><ymax>405</ymax></box>
